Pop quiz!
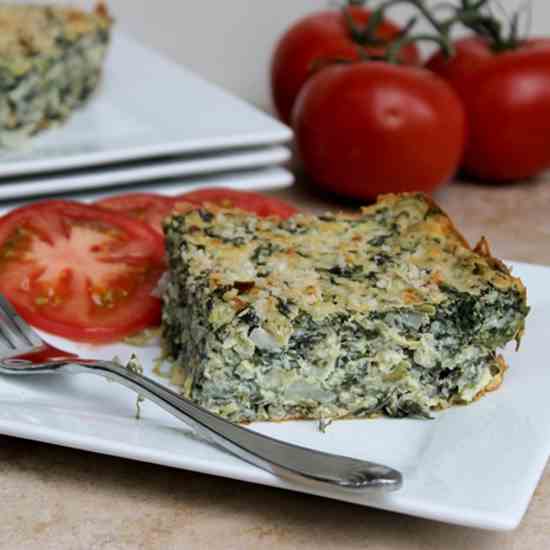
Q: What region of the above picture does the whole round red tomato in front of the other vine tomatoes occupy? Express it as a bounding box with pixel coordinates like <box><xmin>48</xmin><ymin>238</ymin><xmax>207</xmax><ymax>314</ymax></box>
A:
<box><xmin>293</xmin><ymin>62</ymin><xmax>465</xmax><ymax>199</ymax></box>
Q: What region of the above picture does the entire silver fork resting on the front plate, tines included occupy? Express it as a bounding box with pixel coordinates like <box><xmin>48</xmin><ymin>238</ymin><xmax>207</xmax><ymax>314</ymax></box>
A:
<box><xmin>0</xmin><ymin>294</ymin><xmax>402</xmax><ymax>491</ymax></box>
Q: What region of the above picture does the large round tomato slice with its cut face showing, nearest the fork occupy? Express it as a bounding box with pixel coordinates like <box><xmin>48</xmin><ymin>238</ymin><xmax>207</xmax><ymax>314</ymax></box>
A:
<box><xmin>0</xmin><ymin>201</ymin><xmax>164</xmax><ymax>342</ymax></box>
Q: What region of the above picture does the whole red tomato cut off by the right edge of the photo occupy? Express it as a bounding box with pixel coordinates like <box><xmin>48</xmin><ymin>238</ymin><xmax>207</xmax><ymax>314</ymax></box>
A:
<box><xmin>427</xmin><ymin>37</ymin><xmax>550</xmax><ymax>181</ymax></box>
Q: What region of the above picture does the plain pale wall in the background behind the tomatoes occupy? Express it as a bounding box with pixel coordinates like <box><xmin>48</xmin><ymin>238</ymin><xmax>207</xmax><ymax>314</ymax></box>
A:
<box><xmin>43</xmin><ymin>0</ymin><xmax>550</xmax><ymax>112</ymax></box>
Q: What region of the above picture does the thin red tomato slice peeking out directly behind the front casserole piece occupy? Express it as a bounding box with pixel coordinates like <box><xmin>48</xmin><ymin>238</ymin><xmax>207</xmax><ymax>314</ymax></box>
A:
<box><xmin>177</xmin><ymin>187</ymin><xmax>298</xmax><ymax>219</ymax></box>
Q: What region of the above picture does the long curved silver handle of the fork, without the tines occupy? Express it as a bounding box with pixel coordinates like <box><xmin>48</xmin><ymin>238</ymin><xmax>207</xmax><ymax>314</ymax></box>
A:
<box><xmin>15</xmin><ymin>359</ymin><xmax>402</xmax><ymax>492</ymax></box>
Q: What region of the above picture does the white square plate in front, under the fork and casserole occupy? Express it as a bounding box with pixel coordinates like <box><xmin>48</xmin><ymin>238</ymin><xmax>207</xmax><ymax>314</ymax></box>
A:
<box><xmin>0</xmin><ymin>264</ymin><xmax>550</xmax><ymax>530</ymax></box>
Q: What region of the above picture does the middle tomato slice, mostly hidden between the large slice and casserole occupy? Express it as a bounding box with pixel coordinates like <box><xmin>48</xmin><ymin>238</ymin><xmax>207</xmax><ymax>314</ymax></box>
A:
<box><xmin>95</xmin><ymin>193</ymin><xmax>174</xmax><ymax>235</ymax></box>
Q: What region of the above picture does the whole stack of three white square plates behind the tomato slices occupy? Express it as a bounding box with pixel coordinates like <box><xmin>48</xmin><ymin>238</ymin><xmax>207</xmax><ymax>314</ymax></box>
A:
<box><xmin>0</xmin><ymin>32</ymin><xmax>293</xmax><ymax>201</ymax></box>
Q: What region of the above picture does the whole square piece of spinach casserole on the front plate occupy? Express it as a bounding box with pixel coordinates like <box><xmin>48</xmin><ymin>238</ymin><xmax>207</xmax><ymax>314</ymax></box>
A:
<box><xmin>162</xmin><ymin>195</ymin><xmax>528</xmax><ymax>422</ymax></box>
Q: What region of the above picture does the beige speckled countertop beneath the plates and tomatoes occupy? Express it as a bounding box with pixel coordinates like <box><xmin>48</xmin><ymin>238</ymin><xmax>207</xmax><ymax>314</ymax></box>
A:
<box><xmin>0</xmin><ymin>176</ymin><xmax>550</xmax><ymax>550</ymax></box>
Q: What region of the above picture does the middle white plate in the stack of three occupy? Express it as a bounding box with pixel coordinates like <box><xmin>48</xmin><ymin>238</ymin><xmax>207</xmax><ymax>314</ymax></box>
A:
<box><xmin>0</xmin><ymin>146</ymin><xmax>290</xmax><ymax>201</ymax></box>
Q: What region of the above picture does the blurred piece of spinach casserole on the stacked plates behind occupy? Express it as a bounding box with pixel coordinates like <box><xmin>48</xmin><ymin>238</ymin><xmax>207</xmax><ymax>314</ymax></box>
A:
<box><xmin>0</xmin><ymin>4</ymin><xmax>111</xmax><ymax>147</ymax></box>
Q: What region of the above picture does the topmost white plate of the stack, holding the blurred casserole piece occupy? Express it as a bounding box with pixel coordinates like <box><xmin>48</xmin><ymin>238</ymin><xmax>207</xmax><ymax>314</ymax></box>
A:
<box><xmin>0</xmin><ymin>30</ymin><xmax>291</xmax><ymax>178</ymax></box>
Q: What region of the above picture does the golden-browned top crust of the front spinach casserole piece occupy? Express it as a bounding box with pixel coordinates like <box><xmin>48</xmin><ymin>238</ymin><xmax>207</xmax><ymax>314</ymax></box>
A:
<box><xmin>176</xmin><ymin>195</ymin><xmax>524</xmax><ymax>341</ymax></box>
